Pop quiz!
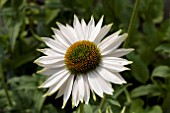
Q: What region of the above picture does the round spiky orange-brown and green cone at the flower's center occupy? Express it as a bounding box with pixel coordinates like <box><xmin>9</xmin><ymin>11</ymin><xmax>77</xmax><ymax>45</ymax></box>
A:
<box><xmin>65</xmin><ymin>40</ymin><xmax>101</xmax><ymax>74</ymax></box>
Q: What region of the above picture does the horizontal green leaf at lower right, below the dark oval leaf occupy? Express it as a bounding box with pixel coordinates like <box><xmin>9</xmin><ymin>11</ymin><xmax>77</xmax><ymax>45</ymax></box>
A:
<box><xmin>131</xmin><ymin>84</ymin><xmax>161</xmax><ymax>97</ymax></box>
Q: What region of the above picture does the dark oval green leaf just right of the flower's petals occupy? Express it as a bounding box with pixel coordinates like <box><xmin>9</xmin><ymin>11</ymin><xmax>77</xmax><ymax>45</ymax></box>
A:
<box><xmin>127</xmin><ymin>53</ymin><xmax>149</xmax><ymax>83</ymax></box>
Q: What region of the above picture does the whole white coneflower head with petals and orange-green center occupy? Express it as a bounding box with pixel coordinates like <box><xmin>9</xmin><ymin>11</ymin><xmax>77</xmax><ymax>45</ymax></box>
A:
<box><xmin>35</xmin><ymin>16</ymin><xmax>133</xmax><ymax>107</ymax></box>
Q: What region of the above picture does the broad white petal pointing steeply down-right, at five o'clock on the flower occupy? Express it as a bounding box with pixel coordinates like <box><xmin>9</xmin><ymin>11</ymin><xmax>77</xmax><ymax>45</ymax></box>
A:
<box><xmin>87</xmin><ymin>71</ymin><xmax>103</xmax><ymax>97</ymax></box>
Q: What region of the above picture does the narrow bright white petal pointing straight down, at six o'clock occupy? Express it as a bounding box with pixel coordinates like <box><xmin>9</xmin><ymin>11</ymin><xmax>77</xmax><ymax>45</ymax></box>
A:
<box><xmin>77</xmin><ymin>75</ymin><xmax>85</xmax><ymax>102</ymax></box>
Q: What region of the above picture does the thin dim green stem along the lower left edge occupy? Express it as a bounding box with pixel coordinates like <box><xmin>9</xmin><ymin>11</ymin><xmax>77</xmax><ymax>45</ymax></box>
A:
<box><xmin>0</xmin><ymin>62</ymin><xmax>12</xmax><ymax>106</ymax></box>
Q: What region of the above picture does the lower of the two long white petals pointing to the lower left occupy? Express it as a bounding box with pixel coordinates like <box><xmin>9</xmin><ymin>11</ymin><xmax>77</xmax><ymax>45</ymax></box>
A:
<box><xmin>46</xmin><ymin>73</ymin><xmax>70</xmax><ymax>96</ymax></box>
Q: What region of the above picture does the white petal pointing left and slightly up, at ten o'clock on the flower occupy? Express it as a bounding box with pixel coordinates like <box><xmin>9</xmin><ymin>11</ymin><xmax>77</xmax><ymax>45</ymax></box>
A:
<box><xmin>42</xmin><ymin>38</ymin><xmax>66</xmax><ymax>54</ymax></box>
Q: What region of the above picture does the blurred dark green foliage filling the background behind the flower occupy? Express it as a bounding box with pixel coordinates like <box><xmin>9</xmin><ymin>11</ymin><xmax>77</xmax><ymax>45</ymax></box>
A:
<box><xmin>0</xmin><ymin>0</ymin><xmax>170</xmax><ymax>113</ymax></box>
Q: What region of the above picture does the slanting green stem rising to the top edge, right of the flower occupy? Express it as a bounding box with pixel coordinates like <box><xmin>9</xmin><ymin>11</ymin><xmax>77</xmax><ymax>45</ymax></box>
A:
<box><xmin>123</xmin><ymin>0</ymin><xmax>140</xmax><ymax>48</ymax></box>
